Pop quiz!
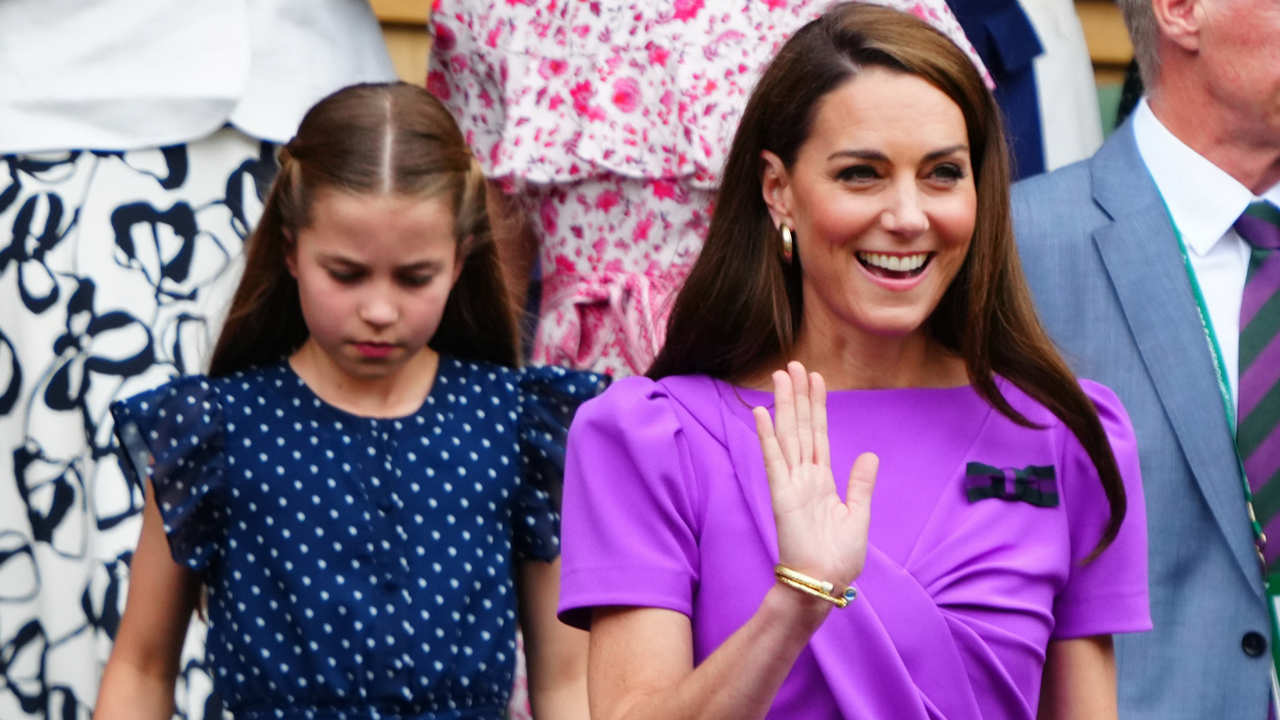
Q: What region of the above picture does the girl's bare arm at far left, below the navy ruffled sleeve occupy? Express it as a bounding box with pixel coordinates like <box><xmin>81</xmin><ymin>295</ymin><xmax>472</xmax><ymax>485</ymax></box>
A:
<box><xmin>93</xmin><ymin>483</ymin><xmax>200</xmax><ymax>720</ymax></box>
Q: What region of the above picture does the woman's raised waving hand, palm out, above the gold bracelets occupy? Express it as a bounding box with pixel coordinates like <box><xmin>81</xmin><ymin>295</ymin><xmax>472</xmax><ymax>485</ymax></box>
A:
<box><xmin>751</xmin><ymin>361</ymin><xmax>879</xmax><ymax>585</ymax></box>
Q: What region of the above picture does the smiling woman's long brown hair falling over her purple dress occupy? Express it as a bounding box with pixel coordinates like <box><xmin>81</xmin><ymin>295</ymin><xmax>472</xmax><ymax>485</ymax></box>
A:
<box><xmin>648</xmin><ymin>3</ymin><xmax>1125</xmax><ymax>559</ymax></box>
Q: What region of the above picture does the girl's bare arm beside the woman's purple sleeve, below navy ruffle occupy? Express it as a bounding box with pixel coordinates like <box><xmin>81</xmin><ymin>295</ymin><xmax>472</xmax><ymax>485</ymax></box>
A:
<box><xmin>520</xmin><ymin>557</ymin><xmax>589</xmax><ymax>720</ymax></box>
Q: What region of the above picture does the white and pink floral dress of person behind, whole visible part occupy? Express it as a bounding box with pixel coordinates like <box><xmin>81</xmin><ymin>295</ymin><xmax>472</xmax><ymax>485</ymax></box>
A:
<box><xmin>428</xmin><ymin>0</ymin><xmax>986</xmax><ymax>375</ymax></box>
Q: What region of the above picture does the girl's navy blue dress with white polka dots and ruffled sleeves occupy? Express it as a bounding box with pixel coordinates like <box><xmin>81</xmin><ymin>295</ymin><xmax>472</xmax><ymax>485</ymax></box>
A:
<box><xmin>111</xmin><ymin>356</ymin><xmax>603</xmax><ymax>720</ymax></box>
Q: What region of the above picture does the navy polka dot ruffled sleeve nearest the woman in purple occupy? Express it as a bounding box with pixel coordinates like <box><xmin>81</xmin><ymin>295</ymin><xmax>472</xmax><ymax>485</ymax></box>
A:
<box><xmin>513</xmin><ymin>366</ymin><xmax>608</xmax><ymax>560</ymax></box>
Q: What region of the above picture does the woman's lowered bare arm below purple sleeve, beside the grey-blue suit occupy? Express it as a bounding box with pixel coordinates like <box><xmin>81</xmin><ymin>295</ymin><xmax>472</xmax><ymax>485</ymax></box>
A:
<box><xmin>1037</xmin><ymin>635</ymin><xmax>1119</xmax><ymax>720</ymax></box>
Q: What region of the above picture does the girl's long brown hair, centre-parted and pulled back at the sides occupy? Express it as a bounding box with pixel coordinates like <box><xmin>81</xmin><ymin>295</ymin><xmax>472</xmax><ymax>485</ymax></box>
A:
<box><xmin>209</xmin><ymin>82</ymin><xmax>520</xmax><ymax>377</ymax></box>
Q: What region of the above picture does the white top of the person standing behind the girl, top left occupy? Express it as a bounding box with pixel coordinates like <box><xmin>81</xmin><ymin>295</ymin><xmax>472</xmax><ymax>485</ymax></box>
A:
<box><xmin>0</xmin><ymin>0</ymin><xmax>396</xmax><ymax>154</ymax></box>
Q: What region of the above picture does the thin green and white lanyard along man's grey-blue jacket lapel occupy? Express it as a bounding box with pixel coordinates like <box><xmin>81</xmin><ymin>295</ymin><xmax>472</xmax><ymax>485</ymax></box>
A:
<box><xmin>1165</xmin><ymin>198</ymin><xmax>1280</xmax><ymax>691</ymax></box>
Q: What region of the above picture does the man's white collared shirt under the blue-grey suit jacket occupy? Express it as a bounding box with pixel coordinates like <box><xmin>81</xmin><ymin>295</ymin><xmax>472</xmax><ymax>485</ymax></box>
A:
<box><xmin>1133</xmin><ymin>97</ymin><xmax>1280</xmax><ymax>406</ymax></box>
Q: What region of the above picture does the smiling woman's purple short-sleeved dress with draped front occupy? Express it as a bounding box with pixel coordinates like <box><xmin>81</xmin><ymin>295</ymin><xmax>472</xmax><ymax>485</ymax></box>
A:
<box><xmin>561</xmin><ymin>377</ymin><xmax>1151</xmax><ymax>720</ymax></box>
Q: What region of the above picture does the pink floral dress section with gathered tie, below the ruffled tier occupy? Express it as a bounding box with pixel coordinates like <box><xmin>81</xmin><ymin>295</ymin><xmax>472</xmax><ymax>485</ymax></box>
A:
<box><xmin>512</xmin><ymin>176</ymin><xmax>714</xmax><ymax>377</ymax></box>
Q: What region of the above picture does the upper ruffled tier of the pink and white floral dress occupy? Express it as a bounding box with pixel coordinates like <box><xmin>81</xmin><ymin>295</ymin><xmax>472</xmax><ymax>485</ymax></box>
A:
<box><xmin>428</xmin><ymin>0</ymin><xmax>987</xmax><ymax>190</ymax></box>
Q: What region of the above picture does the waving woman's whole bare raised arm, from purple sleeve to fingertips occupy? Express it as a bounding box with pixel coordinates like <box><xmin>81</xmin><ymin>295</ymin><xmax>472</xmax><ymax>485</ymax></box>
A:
<box><xmin>588</xmin><ymin>363</ymin><xmax>877</xmax><ymax>720</ymax></box>
